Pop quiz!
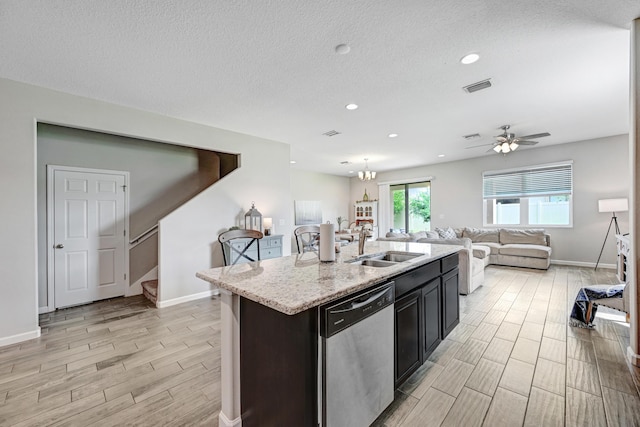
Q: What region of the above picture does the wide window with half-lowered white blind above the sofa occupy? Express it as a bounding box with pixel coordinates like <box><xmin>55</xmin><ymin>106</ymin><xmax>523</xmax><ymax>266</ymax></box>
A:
<box><xmin>482</xmin><ymin>162</ymin><xmax>573</xmax><ymax>227</ymax></box>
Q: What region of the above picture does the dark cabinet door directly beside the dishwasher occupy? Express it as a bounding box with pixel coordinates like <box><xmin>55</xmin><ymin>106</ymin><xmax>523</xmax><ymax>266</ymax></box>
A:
<box><xmin>395</xmin><ymin>289</ymin><xmax>422</xmax><ymax>386</ymax></box>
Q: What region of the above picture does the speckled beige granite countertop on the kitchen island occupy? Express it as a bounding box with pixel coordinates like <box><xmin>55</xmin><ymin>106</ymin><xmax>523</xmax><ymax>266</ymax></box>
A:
<box><xmin>196</xmin><ymin>241</ymin><xmax>461</xmax><ymax>315</ymax></box>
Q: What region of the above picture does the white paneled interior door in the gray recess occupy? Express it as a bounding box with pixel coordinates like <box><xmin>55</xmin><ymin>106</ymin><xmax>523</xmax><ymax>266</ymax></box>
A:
<box><xmin>53</xmin><ymin>170</ymin><xmax>126</xmax><ymax>308</ymax></box>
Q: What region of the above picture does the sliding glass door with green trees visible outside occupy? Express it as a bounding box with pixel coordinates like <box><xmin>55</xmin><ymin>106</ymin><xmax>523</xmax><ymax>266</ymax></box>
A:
<box><xmin>389</xmin><ymin>181</ymin><xmax>431</xmax><ymax>233</ymax></box>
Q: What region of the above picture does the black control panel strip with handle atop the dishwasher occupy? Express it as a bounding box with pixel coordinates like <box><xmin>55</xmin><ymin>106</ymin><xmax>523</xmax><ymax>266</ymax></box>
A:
<box><xmin>321</xmin><ymin>282</ymin><xmax>394</xmax><ymax>338</ymax></box>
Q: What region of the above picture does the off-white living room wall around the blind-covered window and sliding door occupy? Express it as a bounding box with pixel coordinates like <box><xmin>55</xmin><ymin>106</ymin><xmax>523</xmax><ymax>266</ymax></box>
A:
<box><xmin>351</xmin><ymin>135</ymin><xmax>629</xmax><ymax>266</ymax></box>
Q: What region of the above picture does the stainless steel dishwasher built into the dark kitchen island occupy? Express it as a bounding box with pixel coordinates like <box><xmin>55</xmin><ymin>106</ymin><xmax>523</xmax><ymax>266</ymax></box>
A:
<box><xmin>320</xmin><ymin>282</ymin><xmax>394</xmax><ymax>427</ymax></box>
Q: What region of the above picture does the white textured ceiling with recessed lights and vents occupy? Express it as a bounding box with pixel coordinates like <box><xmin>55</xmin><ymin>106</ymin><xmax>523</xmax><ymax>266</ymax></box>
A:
<box><xmin>0</xmin><ymin>0</ymin><xmax>640</xmax><ymax>176</ymax></box>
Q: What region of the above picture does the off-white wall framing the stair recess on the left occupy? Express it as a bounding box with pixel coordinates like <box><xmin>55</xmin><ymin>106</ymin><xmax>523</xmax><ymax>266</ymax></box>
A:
<box><xmin>0</xmin><ymin>79</ymin><xmax>291</xmax><ymax>345</ymax></box>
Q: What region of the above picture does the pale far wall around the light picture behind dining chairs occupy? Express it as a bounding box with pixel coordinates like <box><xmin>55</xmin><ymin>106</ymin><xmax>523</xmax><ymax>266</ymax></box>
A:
<box><xmin>290</xmin><ymin>169</ymin><xmax>355</xmax><ymax>252</ymax></box>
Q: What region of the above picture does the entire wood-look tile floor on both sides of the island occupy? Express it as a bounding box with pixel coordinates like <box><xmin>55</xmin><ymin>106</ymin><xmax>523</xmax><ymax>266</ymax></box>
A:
<box><xmin>0</xmin><ymin>266</ymin><xmax>640</xmax><ymax>427</ymax></box>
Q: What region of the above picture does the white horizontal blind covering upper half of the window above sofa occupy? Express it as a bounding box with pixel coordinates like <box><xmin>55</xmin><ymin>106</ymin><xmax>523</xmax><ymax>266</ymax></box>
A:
<box><xmin>482</xmin><ymin>163</ymin><xmax>573</xmax><ymax>199</ymax></box>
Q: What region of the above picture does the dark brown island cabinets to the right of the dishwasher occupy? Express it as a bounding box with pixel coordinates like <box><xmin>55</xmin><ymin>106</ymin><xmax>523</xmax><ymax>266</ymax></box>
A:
<box><xmin>393</xmin><ymin>254</ymin><xmax>460</xmax><ymax>387</ymax></box>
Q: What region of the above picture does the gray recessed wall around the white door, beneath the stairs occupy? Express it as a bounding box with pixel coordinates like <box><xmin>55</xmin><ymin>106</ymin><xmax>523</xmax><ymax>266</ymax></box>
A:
<box><xmin>37</xmin><ymin>123</ymin><xmax>225</xmax><ymax>307</ymax></box>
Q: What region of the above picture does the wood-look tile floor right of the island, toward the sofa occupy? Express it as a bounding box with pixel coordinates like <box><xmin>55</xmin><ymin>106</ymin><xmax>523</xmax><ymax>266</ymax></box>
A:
<box><xmin>374</xmin><ymin>266</ymin><xmax>640</xmax><ymax>427</ymax></box>
